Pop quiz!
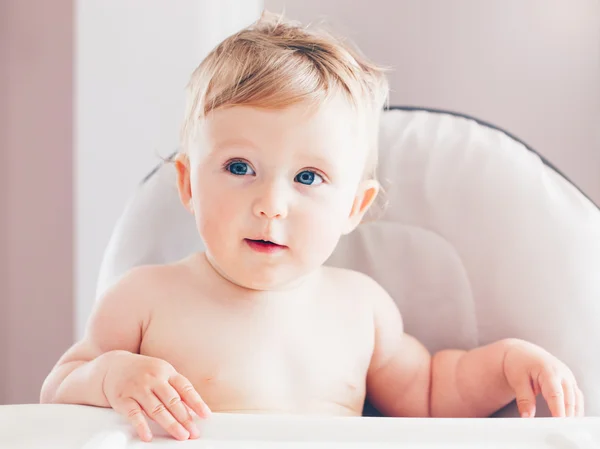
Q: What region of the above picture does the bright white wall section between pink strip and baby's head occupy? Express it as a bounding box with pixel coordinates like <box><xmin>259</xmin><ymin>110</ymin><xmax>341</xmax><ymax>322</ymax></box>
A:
<box><xmin>75</xmin><ymin>0</ymin><xmax>262</xmax><ymax>336</ymax></box>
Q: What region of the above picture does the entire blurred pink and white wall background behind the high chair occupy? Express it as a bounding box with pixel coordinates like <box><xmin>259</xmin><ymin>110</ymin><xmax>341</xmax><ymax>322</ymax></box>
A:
<box><xmin>0</xmin><ymin>0</ymin><xmax>600</xmax><ymax>404</ymax></box>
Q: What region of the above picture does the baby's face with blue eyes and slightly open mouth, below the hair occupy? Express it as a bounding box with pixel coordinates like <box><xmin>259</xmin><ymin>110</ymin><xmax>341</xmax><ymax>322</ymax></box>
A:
<box><xmin>180</xmin><ymin>98</ymin><xmax>377</xmax><ymax>290</ymax></box>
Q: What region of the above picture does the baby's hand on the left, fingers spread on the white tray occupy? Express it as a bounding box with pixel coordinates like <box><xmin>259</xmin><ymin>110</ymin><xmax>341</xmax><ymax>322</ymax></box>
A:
<box><xmin>103</xmin><ymin>352</ymin><xmax>210</xmax><ymax>441</ymax></box>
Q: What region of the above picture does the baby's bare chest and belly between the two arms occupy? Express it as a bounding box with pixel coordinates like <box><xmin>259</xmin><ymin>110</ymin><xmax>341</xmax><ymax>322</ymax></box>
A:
<box><xmin>142</xmin><ymin>294</ymin><xmax>373</xmax><ymax>413</ymax></box>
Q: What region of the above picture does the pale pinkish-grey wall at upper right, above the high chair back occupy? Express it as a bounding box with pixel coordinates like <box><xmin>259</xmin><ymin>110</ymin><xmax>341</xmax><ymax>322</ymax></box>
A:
<box><xmin>265</xmin><ymin>0</ymin><xmax>600</xmax><ymax>204</ymax></box>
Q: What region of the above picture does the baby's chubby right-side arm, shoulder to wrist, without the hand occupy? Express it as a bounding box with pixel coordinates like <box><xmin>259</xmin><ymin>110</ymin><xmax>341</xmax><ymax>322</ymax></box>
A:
<box><xmin>367</xmin><ymin>286</ymin><xmax>515</xmax><ymax>417</ymax></box>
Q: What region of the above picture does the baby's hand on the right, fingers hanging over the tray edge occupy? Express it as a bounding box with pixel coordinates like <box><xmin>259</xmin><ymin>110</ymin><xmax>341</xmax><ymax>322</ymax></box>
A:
<box><xmin>504</xmin><ymin>341</ymin><xmax>583</xmax><ymax>418</ymax></box>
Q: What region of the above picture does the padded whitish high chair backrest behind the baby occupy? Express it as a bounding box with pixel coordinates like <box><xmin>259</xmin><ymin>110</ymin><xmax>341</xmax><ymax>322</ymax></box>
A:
<box><xmin>98</xmin><ymin>108</ymin><xmax>600</xmax><ymax>416</ymax></box>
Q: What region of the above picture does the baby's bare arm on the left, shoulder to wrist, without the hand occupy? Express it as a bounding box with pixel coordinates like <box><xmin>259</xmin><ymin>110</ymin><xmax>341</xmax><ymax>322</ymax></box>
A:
<box><xmin>40</xmin><ymin>270</ymin><xmax>149</xmax><ymax>407</ymax></box>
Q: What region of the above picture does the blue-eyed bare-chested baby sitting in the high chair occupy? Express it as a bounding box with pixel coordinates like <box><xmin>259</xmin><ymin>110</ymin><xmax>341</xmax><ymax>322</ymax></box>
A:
<box><xmin>41</xmin><ymin>10</ymin><xmax>583</xmax><ymax>441</ymax></box>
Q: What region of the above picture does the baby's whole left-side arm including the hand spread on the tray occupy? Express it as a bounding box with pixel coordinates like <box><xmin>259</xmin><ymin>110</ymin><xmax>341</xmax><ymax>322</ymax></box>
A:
<box><xmin>40</xmin><ymin>267</ymin><xmax>210</xmax><ymax>441</ymax></box>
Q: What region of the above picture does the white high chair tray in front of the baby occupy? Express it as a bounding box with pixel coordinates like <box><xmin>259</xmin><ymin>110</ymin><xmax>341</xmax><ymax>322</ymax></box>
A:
<box><xmin>0</xmin><ymin>405</ymin><xmax>600</xmax><ymax>449</ymax></box>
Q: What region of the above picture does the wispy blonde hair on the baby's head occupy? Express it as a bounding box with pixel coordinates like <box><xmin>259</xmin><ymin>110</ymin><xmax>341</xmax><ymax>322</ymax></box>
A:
<box><xmin>181</xmin><ymin>12</ymin><xmax>389</xmax><ymax>177</ymax></box>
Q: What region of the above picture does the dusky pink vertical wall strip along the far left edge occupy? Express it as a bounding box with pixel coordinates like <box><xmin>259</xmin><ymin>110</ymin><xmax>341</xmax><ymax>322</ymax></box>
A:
<box><xmin>0</xmin><ymin>0</ymin><xmax>73</xmax><ymax>404</ymax></box>
